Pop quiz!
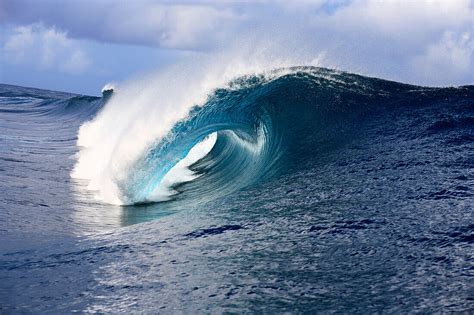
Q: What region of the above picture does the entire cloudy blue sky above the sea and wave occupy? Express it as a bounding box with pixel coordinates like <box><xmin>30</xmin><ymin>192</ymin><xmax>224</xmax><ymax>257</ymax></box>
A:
<box><xmin>0</xmin><ymin>0</ymin><xmax>474</xmax><ymax>95</ymax></box>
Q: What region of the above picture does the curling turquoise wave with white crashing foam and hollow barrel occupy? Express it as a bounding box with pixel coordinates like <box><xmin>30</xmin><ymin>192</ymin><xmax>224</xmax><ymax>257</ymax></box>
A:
<box><xmin>73</xmin><ymin>67</ymin><xmax>472</xmax><ymax>205</ymax></box>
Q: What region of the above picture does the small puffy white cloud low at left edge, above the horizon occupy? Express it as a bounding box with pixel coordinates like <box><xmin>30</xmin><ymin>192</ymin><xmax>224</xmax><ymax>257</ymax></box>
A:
<box><xmin>2</xmin><ymin>24</ymin><xmax>90</xmax><ymax>74</ymax></box>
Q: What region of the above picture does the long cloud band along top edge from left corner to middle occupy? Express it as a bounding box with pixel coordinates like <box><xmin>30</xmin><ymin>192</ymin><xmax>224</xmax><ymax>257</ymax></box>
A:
<box><xmin>0</xmin><ymin>0</ymin><xmax>241</xmax><ymax>49</ymax></box>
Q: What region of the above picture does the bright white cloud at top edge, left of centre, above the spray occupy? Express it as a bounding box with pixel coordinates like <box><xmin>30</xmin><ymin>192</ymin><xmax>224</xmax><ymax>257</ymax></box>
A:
<box><xmin>96</xmin><ymin>2</ymin><xmax>243</xmax><ymax>49</ymax></box>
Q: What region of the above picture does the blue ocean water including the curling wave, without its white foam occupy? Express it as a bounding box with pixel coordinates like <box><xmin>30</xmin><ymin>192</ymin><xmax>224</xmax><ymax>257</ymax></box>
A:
<box><xmin>0</xmin><ymin>67</ymin><xmax>474</xmax><ymax>313</ymax></box>
